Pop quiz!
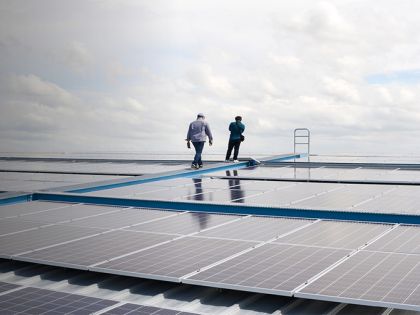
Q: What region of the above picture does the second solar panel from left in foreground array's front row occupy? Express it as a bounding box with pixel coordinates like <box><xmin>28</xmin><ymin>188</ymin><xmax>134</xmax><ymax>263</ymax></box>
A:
<box><xmin>14</xmin><ymin>231</ymin><xmax>174</xmax><ymax>269</ymax></box>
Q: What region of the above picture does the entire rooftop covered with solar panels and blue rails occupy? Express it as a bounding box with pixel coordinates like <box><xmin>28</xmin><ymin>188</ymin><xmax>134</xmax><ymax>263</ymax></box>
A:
<box><xmin>0</xmin><ymin>152</ymin><xmax>420</xmax><ymax>315</ymax></box>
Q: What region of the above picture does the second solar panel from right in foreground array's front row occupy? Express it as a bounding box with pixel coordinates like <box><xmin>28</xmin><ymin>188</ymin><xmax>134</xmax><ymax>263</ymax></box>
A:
<box><xmin>182</xmin><ymin>243</ymin><xmax>350</xmax><ymax>296</ymax></box>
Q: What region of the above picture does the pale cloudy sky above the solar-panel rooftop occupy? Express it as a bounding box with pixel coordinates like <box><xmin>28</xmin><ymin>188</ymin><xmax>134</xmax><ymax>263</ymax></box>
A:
<box><xmin>0</xmin><ymin>0</ymin><xmax>420</xmax><ymax>154</ymax></box>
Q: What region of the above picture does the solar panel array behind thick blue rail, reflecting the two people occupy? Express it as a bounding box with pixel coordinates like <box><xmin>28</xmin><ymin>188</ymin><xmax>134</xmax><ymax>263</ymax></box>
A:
<box><xmin>79</xmin><ymin>167</ymin><xmax>420</xmax><ymax>214</ymax></box>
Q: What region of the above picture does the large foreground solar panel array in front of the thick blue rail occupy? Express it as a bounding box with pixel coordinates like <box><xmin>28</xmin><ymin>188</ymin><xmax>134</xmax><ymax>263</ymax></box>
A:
<box><xmin>7</xmin><ymin>200</ymin><xmax>420</xmax><ymax>309</ymax></box>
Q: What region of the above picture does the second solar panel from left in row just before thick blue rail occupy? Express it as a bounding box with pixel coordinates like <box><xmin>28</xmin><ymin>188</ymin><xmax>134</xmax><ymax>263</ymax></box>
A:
<box><xmin>11</xmin><ymin>204</ymin><xmax>124</xmax><ymax>223</ymax></box>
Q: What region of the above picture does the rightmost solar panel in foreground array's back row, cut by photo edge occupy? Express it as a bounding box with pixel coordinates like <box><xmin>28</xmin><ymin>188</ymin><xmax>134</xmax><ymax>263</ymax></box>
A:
<box><xmin>366</xmin><ymin>225</ymin><xmax>420</xmax><ymax>254</ymax></box>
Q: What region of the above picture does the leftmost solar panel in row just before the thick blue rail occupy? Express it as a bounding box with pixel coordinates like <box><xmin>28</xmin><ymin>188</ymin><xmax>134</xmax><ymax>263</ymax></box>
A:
<box><xmin>0</xmin><ymin>201</ymin><xmax>71</xmax><ymax>218</ymax></box>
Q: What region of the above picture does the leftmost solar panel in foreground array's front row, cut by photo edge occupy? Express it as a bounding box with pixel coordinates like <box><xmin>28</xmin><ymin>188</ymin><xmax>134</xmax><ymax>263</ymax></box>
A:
<box><xmin>0</xmin><ymin>225</ymin><xmax>103</xmax><ymax>258</ymax></box>
